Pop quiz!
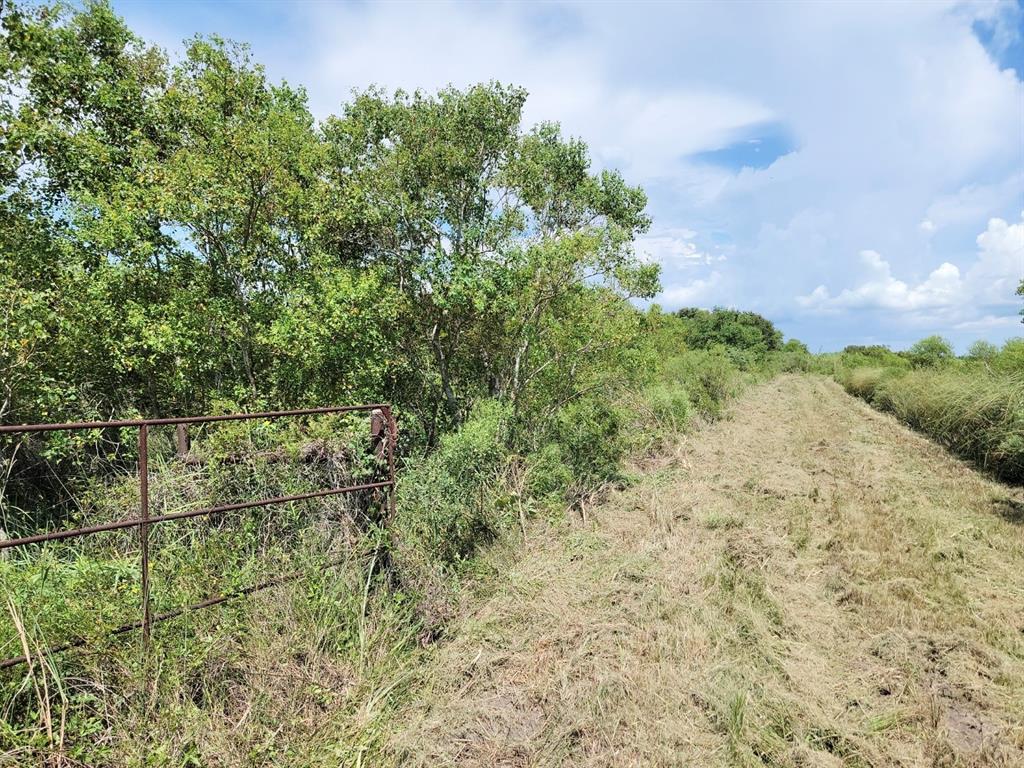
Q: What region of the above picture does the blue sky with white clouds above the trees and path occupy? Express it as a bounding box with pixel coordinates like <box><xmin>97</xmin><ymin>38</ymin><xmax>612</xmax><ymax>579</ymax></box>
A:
<box><xmin>115</xmin><ymin>0</ymin><xmax>1024</xmax><ymax>351</ymax></box>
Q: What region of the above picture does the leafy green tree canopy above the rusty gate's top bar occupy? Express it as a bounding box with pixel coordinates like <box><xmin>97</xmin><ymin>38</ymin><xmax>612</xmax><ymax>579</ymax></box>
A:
<box><xmin>0</xmin><ymin>2</ymin><xmax>655</xmax><ymax>441</ymax></box>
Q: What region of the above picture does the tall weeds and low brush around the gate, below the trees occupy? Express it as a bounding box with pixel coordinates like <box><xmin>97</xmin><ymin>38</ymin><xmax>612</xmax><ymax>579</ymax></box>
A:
<box><xmin>0</xmin><ymin>351</ymin><xmax>768</xmax><ymax>766</ymax></box>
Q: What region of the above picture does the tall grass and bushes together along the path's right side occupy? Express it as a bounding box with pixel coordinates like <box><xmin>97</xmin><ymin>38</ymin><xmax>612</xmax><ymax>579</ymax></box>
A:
<box><xmin>828</xmin><ymin>336</ymin><xmax>1024</xmax><ymax>482</ymax></box>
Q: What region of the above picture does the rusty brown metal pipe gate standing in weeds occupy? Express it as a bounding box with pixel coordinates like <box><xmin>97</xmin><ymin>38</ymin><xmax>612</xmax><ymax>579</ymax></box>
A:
<box><xmin>0</xmin><ymin>403</ymin><xmax>397</xmax><ymax>670</ymax></box>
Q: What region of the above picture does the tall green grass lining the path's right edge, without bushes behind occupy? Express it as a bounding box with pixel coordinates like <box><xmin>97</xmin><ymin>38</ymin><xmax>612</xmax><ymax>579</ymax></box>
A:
<box><xmin>837</xmin><ymin>366</ymin><xmax>1024</xmax><ymax>482</ymax></box>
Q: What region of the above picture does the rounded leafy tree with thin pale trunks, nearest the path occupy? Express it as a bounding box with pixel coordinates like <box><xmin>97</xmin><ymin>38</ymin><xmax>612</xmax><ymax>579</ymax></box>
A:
<box><xmin>324</xmin><ymin>84</ymin><xmax>657</xmax><ymax>434</ymax></box>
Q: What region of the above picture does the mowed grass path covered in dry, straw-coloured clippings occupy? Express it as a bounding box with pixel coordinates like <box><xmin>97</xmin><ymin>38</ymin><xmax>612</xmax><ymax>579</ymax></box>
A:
<box><xmin>390</xmin><ymin>376</ymin><xmax>1024</xmax><ymax>766</ymax></box>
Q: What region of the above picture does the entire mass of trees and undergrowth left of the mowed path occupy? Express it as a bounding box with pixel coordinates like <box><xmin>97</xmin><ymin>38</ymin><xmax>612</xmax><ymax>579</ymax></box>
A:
<box><xmin>0</xmin><ymin>2</ymin><xmax>790</xmax><ymax>766</ymax></box>
